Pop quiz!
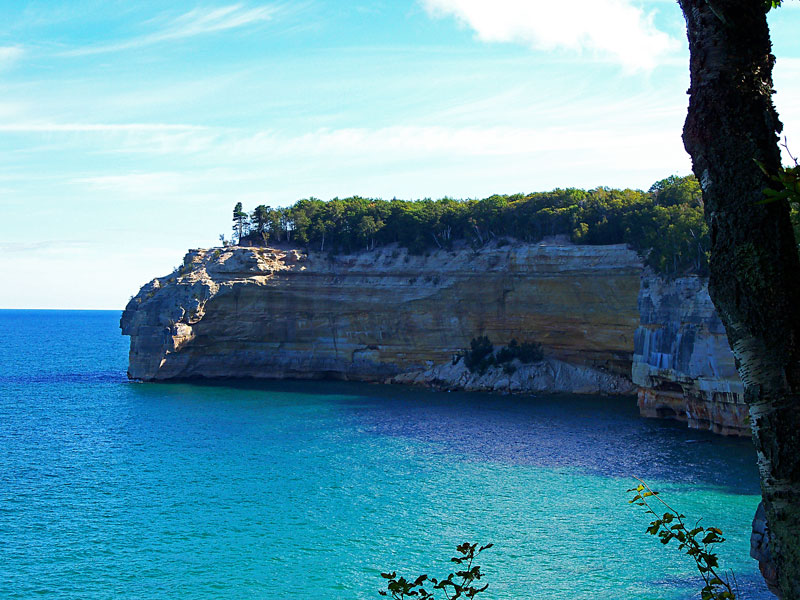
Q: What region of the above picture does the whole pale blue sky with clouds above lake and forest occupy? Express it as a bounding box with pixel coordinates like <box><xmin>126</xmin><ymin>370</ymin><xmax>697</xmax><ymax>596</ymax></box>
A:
<box><xmin>0</xmin><ymin>0</ymin><xmax>800</xmax><ymax>309</ymax></box>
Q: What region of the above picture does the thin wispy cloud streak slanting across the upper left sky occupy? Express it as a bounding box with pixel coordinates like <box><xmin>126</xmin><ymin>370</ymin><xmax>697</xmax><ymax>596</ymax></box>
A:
<box><xmin>63</xmin><ymin>4</ymin><xmax>281</xmax><ymax>56</ymax></box>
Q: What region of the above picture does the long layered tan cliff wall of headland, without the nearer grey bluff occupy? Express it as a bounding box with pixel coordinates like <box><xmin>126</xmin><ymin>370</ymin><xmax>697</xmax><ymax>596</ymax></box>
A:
<box><xmin>121</xmin><ymin>241</ymin><xmax>642</xmax><ymax>392</ymax></box>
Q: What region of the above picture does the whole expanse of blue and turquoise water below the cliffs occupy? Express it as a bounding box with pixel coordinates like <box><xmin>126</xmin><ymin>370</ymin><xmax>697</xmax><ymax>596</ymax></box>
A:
<box><xmin>0</xmin><ymin>311</ymin><xmax>770</xmax><ymax>600</ymax></box>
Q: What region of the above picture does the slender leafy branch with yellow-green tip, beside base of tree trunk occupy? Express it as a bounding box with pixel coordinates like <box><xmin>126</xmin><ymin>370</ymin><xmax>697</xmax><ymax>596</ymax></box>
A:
<box><xmin>628</xmin><ymin>477</ymin><xmax>736</xmax><ymax>600</ymax></box>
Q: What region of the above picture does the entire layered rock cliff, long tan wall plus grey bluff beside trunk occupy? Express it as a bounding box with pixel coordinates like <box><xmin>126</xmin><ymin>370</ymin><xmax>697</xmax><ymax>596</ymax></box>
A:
<box><xmin>121</xmin><ymin>238</ymin><xmax>746</xmax><ymax>433</ymax></box>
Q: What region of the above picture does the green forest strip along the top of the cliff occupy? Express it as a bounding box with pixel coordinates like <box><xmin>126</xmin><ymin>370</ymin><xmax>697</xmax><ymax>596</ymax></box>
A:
<box><xmin>233</xmin><ymin>175</ymin><xmax>764</xmax><ymax>274</ymax></box>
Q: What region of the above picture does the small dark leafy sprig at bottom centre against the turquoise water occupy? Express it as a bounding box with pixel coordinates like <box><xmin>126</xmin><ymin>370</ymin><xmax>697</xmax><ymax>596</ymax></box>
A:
<box><xmin>378</xmin><ymin>542</ymin><xmax>493</xmax><ymax>600</ymax></box>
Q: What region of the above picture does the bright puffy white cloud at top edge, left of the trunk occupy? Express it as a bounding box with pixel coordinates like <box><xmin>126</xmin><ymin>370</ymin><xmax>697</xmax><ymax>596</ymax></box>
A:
<box><xmin>420</xmin><ymin>0</ymin><xmax>678</xmax><ymax>70</ymax></box>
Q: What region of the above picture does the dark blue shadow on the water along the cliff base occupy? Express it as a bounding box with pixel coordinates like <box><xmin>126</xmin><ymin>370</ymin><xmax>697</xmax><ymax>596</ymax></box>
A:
<box><xmin>153</xmin><ymin>380</ymin><xmax>760</xmax><ymax>495</ymax></box>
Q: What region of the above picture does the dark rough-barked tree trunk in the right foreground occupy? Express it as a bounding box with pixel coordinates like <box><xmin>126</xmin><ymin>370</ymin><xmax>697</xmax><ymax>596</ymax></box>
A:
<box><xmin>679</xmin><ymin>0</ymin><xmax>800</xmax><ymax>599</ymax></box>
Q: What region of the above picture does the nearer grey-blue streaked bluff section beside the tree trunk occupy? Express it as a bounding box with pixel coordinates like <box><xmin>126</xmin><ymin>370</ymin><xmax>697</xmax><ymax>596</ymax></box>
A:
<box><xmin>632</xmin><ymin>272</ymin><xmax>750</xmax><ymax>435</ymax></box>
